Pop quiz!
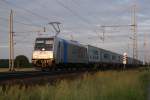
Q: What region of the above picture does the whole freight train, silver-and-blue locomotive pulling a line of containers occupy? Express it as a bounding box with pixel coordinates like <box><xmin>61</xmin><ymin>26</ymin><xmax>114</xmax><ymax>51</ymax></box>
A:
<box><xmin>32</xmin><ymin>37</ymin><xmax>141</xmax><ymax>70</ymax></box>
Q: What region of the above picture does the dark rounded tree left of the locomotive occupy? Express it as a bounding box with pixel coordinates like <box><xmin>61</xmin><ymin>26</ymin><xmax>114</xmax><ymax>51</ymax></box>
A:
<box><xmin>14</xmin><ymin>55</ymin><xmax>30</xmax><ymax>67</ymax></box>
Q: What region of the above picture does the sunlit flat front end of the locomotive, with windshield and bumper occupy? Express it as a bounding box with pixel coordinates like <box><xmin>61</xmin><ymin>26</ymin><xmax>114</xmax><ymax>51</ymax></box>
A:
<box><xmin>32</xmin><ymin>38</ymin><xmax>55</xmax><ymax>68</ymax></box>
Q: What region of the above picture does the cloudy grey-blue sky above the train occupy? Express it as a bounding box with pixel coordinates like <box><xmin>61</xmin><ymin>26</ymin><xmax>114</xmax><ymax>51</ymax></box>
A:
<box><xmin>0</xmin><ymin>0</ymin><xmax>150</xmax><ymax>61</ymax></box>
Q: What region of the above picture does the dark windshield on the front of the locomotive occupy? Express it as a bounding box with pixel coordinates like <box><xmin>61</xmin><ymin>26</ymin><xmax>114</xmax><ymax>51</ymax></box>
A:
<box><xmin>34</xmin><ymin>38</ymin><xmax>54</xmax><ymax>51</ymax></box>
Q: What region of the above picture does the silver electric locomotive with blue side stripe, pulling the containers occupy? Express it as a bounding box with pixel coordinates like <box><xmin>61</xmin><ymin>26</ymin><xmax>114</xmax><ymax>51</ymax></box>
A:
<box><xmin>32</xmin><ymin>37</ymin><xmax>88</xmax><ymax>69</ymax></box>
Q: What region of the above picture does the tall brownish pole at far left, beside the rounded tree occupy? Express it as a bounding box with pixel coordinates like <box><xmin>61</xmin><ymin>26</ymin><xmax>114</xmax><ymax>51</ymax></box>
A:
<box><xmin>9</xmin><ymin>10</ymin><xmax>14</xmax><ymax>71</ymax></box>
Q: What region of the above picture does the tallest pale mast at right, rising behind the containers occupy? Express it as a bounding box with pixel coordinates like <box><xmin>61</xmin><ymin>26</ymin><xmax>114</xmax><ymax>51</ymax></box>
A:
<box><xmin>131</xmin><ymin>5</ymin><xmax>138</xmax><ymax>64</ymax></box>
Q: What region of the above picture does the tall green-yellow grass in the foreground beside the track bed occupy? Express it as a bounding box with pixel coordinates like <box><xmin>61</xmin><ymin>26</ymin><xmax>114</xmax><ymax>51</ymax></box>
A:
<box><xmin>0</xmin><ymin>71</ymin><xmax>149</xmax><ymax>100</ymax></box>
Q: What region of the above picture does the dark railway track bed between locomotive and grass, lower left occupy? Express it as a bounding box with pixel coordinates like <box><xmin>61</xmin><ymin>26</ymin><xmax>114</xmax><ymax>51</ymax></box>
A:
<box><xmin>0</xmin><ymin>70</ymin><xmax>90</xmax><ymax>85</ymax></box>
